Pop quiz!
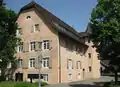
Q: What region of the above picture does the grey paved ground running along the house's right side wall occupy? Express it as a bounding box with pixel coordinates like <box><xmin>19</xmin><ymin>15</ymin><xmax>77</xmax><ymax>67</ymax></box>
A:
<box><xmin>46</xmin><ymin>76</ymin><xmax>114</xmax><ymax>87</ymax></box>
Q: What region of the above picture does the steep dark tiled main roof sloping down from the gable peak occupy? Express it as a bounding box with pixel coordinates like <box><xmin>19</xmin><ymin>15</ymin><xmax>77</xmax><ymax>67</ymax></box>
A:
<box><xmin>19</xmin><ymin>1</ymin><xmax>85</xmax><ymax>45</ymax></box>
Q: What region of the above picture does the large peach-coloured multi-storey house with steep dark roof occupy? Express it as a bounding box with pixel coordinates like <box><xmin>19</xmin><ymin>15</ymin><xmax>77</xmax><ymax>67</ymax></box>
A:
<box><xmin>14</xmin><ymin>1</ymin><xmax>100</xmax><ymax>84</ymax></box>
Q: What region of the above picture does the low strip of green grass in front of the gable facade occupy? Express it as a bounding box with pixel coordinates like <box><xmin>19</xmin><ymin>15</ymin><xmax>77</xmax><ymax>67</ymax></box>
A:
<box><xmin>0</xmin><ymin>82</ymin><xmax>47</xmax><ymax>87</ymax></box>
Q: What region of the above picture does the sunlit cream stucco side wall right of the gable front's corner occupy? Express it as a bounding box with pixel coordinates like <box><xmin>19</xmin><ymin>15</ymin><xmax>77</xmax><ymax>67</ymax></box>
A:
<box><xmin>60</xmin><ymin>37</ymin><xmax>100</xmax><ymax>82</ymax></box>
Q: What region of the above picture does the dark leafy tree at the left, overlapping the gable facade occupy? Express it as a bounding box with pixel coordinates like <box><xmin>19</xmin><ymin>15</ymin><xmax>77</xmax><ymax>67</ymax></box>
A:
<box><xmin>0</xmin><ymin>1</ymin><xmax>19</xmax><ymax>80</ymax></box>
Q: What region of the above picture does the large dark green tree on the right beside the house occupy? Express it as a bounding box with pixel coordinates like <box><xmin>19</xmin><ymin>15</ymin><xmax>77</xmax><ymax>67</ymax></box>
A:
<box><xmin>90</xmin><ymin>0</ymin><xmax>120</xmax><ymax>82</ymax></box>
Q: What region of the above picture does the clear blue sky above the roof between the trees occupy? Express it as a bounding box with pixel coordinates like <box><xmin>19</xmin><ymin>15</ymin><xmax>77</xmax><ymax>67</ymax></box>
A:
<box><xmin>4</xmin><ymin>0</ymin><xmax>97</xmax><ymax>32</ymax></box>
